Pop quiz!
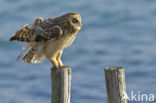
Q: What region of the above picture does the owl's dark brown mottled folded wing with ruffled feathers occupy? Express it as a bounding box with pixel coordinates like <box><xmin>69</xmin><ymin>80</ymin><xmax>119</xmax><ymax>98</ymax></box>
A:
<box><xmin>9</xmin><ymin>18</ymin><xmax>63</xmax><ymax>42</ymax></box>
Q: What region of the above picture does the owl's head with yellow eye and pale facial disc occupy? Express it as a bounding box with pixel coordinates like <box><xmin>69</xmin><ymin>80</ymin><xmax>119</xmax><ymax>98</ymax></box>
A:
<box><xmin>62</xmin><ymin>12</ymin><xmax>82</xmax><ymax>30</ymax></box>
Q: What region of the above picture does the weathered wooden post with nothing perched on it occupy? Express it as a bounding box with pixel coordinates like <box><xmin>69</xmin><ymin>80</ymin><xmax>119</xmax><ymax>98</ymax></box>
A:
<box><xmin>105</xmin><ymin>67</ymin><xmax>128</xmax><ymax>103</ymax></box>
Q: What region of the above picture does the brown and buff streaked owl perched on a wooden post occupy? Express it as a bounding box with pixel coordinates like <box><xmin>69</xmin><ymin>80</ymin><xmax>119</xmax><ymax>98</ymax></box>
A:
<box><xmin>9</xmin><ymin>12</ymin><xmax>82</xmax><ymax>68</ymax></box>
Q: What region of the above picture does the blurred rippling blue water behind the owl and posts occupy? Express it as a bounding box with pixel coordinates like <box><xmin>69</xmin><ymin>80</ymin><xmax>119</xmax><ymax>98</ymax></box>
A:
<box><xmin>0</xmin><ymin>0</ymin><xmax>156</xmax><ymax>103</ymax></box>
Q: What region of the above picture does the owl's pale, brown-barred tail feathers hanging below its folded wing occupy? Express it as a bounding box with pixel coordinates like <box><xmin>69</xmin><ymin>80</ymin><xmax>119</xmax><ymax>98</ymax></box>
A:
<box><xmin>22</xmin><ymin>45</ymin><xmax>45</xmax><ymax>64</ymax></box>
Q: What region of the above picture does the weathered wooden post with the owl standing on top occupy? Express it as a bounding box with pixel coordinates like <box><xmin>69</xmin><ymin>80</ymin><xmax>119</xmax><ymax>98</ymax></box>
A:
<box><xmin>51</xmin><ymin>66</ymin><xmax>71</xmax><ymax>103</ymax></box>
